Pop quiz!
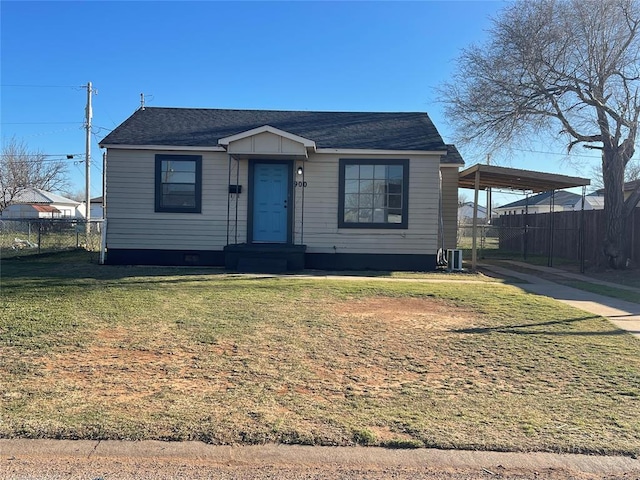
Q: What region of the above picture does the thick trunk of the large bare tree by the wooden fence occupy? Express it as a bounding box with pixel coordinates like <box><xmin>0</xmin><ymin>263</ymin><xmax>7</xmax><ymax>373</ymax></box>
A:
<box><xmin>602</xmin><ymin>147</ymin><xmax>629</xmax><ymax>269</ymax></box>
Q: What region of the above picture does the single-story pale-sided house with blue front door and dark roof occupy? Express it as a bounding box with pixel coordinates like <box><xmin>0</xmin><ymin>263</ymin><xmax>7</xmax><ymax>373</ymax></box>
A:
<box><xmin>100</xmin><ymin>107</ymin><xmax>463</xmax><ymax>270</ymax></box>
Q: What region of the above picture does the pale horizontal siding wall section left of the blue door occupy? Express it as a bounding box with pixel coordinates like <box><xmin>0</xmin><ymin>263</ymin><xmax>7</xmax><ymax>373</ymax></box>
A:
<box><xmin>107</xmin><ymin>149</ymin><xmax>247</xmax><ymax>250</ymax></box>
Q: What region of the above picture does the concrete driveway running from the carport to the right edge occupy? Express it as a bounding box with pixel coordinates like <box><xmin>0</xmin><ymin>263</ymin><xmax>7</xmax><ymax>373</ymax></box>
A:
<box><xmin>479</xmin><ymin>262</ymin><xmax>640</xmax><ymax>338</ymax></box>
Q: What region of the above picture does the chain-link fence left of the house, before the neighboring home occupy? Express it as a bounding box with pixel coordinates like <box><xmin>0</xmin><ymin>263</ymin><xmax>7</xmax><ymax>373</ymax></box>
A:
<box><xmin>0</xmin><ymin>218</ymin><xmax>103</xmax><ymax>258</ymax></box>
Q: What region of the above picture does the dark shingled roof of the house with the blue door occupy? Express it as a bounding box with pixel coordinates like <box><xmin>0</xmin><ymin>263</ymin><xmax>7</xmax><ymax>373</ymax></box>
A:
<box><xmin>100</xmin><ymin>107</ymin><xmax>461</xmax><ymax>157</ymax></box>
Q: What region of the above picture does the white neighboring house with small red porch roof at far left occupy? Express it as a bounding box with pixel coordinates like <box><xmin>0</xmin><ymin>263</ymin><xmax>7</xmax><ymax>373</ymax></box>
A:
<box><xmin>0</xmin><ymin>188</ymin><xmax>82</xmax><ymax>219</ymax></box>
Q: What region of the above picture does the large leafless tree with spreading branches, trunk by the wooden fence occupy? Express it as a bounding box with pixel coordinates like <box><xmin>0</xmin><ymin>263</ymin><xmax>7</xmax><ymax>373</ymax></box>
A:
<box><xmin>441</xmin><ymin>0</ymin><xmax>640</xmax><ymax>268</ymax></box>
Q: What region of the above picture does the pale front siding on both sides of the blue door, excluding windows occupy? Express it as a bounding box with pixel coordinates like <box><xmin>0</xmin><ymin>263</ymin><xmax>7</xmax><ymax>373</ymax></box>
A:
<box><xmin>107</xmin><ymin>149</ymin><xmax>439</xmax><ymax>254</ymax></box>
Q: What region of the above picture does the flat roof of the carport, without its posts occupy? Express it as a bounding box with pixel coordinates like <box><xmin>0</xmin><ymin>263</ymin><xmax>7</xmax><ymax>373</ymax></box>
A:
<box><xmin>458</xmin><ymin>163</ymin><xmax>591</xmax><ymax>193</ymax></box>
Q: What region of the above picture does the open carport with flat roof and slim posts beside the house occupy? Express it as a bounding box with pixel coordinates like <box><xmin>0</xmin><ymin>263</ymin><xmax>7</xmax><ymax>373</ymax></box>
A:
<box><xmin>458</xmin><ymin>163</ymin><xmax>591</xmax><ymax>271</ymax></box>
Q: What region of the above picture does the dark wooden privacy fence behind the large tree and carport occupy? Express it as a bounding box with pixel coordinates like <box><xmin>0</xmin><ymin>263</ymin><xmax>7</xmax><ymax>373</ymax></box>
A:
<box><xmin>493</xmin><ymin>208</ymin><xmax>640</xmax><ymax>267</ymax></box>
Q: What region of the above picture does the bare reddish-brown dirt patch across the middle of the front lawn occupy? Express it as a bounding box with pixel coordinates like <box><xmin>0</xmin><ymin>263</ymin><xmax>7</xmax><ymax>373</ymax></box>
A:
<box><xmin>33</xmin><ymin>297</ymin><xmax>473</xmax><ymax>406</ymax></box>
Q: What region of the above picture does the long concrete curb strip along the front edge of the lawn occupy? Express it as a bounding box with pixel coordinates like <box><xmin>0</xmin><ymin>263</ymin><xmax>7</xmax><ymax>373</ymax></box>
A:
<box><xmin>0</xmin><ymin>439</ymin><xmax>640</xmax><ymax>475</ymax></box>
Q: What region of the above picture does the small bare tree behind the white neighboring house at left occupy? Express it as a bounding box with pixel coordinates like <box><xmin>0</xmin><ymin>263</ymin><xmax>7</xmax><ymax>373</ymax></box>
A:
<box><xmin>0</xmin><ymin>137</ymin><xmax>68</xmax><ymax>212</ymax></box>
